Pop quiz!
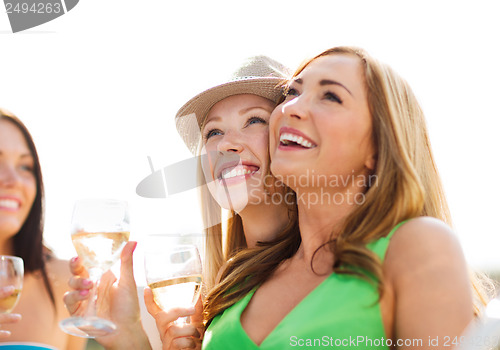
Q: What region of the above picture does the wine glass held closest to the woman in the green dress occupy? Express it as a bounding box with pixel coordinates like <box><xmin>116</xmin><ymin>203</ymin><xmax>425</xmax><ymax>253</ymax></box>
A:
<box><xmin>144</xmin><ymin>236</ymin><xmax>202</xmax><ymax>324</ymax></box>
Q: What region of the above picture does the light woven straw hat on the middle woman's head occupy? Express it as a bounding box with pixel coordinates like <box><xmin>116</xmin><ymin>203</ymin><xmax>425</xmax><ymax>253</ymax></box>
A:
<box><xmin>175</xmin><ymin>56</ymin><xmax>290</xmax><ymax>154</ymax></box>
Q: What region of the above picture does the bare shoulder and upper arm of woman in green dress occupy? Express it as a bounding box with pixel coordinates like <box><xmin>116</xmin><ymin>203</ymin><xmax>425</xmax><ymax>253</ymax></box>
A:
<box><xmin>383</xmin><ymin>221</ymin><xmax>474</xmax><ymax>349</ymax></box>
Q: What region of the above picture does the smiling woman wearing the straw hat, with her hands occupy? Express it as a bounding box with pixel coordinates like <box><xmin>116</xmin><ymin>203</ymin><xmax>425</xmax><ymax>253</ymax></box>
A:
<box><xmin>65</xmin><ymin>56</ymin><xmax>297</xmax><ymax>348</ymax></box>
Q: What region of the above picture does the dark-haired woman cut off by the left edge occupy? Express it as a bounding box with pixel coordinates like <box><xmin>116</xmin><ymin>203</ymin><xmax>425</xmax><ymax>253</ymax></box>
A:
<box><xmin>0</xmin><ymin>109</ymin><xmax>85</xmax><ymax>349</ymax></box>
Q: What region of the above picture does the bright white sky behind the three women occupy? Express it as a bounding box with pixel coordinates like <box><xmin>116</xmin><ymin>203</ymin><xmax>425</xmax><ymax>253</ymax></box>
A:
<box><xmin>0</xmin><ymin>0</ymin><xmax>500</xmax><ymax>286</ymax></box>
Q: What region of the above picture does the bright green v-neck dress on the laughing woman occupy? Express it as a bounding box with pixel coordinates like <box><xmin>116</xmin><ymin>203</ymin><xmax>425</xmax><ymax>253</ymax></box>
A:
<box><xmin>202</xmin><ymin>222</ymin><xmax>403</xmax><ymax>350</ymax></box>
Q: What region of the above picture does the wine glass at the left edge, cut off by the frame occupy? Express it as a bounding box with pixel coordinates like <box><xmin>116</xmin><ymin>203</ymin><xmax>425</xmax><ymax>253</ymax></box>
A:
<box><xmin>0</xmin><ymin>255</ymin><xmax>24</xmax><ymax>313</ymax></box>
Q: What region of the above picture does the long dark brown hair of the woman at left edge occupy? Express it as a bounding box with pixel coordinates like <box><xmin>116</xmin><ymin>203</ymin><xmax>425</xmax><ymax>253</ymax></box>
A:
<box><xmin>0</xmin><ymin>108</ymin><xmax>56</xmax><ymax>309</ymax></box>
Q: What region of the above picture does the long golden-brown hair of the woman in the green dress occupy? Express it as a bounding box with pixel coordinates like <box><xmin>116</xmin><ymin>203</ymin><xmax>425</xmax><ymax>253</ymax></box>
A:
<box><xmin>204</xmin><ymin>47</ymin><xmax>492</xmax><ymax>326</ymax></box>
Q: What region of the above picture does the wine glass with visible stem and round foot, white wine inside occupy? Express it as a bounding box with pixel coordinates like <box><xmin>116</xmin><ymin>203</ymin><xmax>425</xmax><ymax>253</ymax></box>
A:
<box><xmin>60</xmin><ymin>199</ymin><xmax>130</xmax><ymax>338</ymax></box>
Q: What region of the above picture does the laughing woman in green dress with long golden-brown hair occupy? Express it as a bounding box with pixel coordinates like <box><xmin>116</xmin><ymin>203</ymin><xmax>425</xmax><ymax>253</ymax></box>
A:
<box><xmin>203</xmin><ymin>47</ymin><xmax>490</xmax><ymax>350</ymax></box>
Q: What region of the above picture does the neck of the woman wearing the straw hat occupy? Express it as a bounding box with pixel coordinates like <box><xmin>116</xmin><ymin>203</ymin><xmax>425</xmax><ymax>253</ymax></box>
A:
<box><xmin>238</xmin><ymin>203</ymin><xmax>288</xmax><ymax>248</ymax></box>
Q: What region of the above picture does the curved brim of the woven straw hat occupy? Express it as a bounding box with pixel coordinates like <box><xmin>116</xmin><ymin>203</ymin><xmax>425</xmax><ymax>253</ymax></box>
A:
<box><xmin>175</xmin><ymin>77</ymin><xmax>284</xmax><ymax>154</ymax></box>
